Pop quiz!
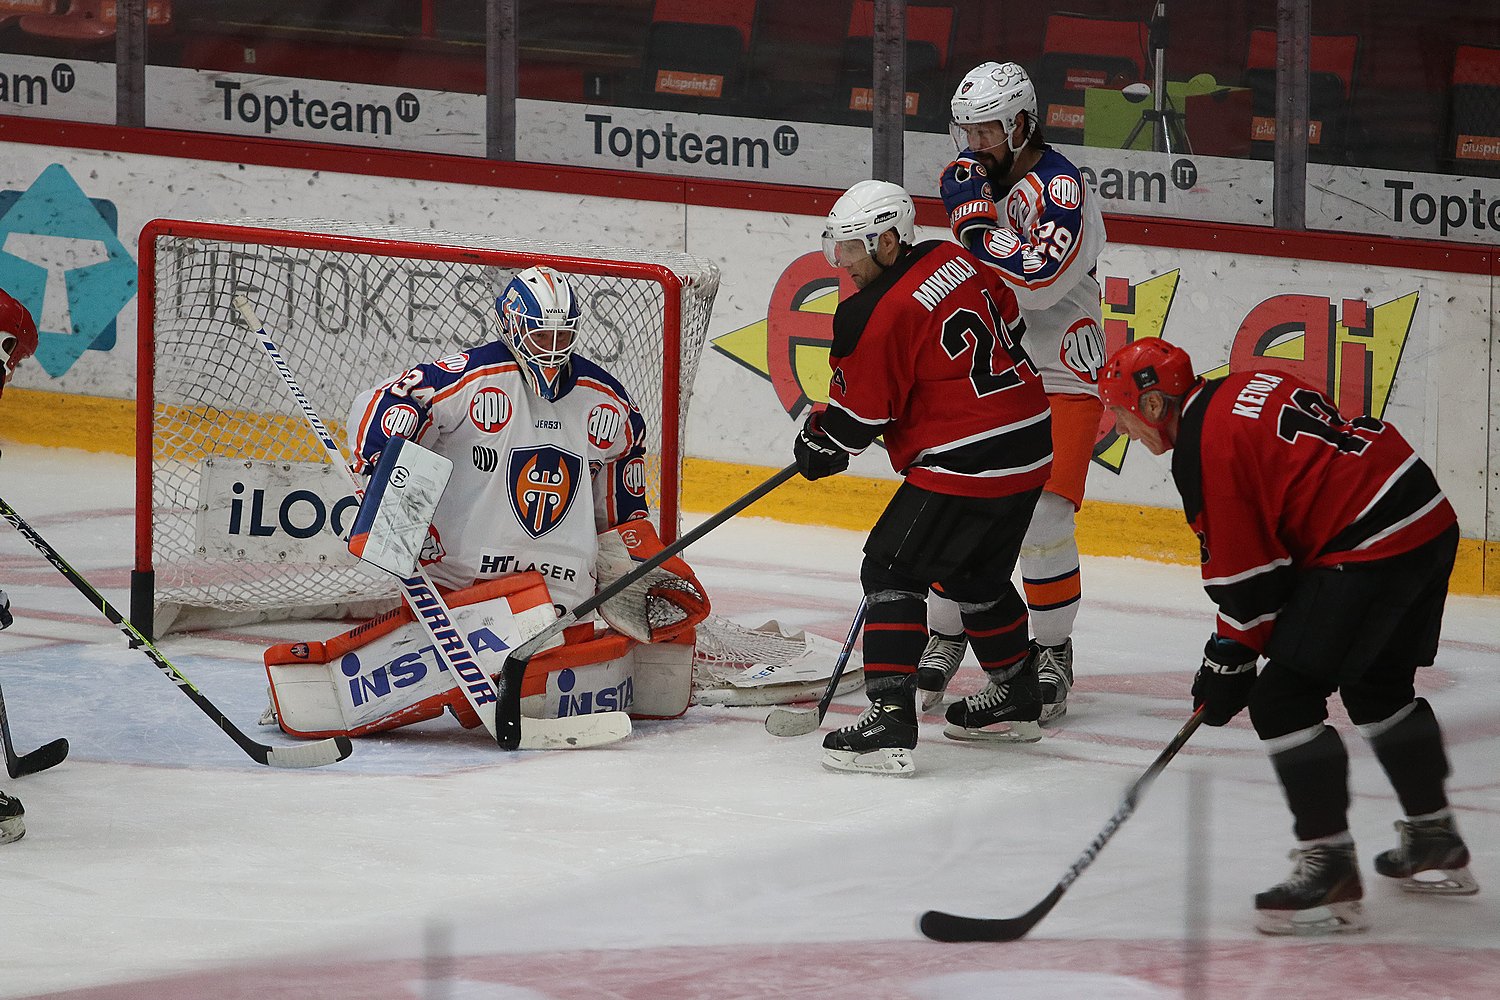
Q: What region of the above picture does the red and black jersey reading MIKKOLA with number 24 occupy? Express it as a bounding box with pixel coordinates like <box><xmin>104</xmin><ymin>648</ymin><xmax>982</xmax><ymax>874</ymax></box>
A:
<box><xmin>822</xmin><ymin>240</ymin><xmax>1052</xmax><ymax>496</ymax></box>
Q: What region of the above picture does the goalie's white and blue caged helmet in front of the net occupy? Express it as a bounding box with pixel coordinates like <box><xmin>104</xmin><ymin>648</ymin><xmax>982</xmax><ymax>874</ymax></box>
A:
<box><xmin>495</xmin><ymin>267</ymin><xmax>579</xmax><ymax>399</ymax></box>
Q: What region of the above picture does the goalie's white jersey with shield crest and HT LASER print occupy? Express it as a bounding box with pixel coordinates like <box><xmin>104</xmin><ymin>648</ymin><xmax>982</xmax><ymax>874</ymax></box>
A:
<box><xmin>350</xmin><ymin>342</ymin><xmax>647</xmax><ymax>607</ymax></box>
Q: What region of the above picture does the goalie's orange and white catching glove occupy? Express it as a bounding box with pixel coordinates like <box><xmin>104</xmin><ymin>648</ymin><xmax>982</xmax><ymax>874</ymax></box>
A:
<box><xmin>599</xmin><ymin>517</ymin><xmax>710</xmax><ymax>642</ymax></box>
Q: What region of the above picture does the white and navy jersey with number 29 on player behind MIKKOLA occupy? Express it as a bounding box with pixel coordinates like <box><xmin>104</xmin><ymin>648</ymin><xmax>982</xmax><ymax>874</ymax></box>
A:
<box><xmin>969</xmin><ymin>145</ymin><xmax>1106</xmax><ymax>396</ymax></box>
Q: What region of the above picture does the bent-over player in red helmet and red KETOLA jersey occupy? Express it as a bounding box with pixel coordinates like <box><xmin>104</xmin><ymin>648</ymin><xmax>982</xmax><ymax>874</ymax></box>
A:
<box><xmin>1100</xmin><ymin>337</ymin><xmax>1479</xmax><ymax>934</ymax></box>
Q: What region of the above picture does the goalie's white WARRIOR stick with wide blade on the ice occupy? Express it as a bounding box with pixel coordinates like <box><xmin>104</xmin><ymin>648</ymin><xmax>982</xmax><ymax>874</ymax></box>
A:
<box><xmin>234</xmin><ymin>294</ymin><xmax>630</xmax><ymax>750</ymax></box>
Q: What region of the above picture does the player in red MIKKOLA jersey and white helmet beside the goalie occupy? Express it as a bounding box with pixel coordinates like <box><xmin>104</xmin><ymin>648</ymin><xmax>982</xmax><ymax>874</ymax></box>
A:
<box><xmin>795</xmin><ymin>180</ymin><xmax>1052</xmax><ymax>775</ymax></box>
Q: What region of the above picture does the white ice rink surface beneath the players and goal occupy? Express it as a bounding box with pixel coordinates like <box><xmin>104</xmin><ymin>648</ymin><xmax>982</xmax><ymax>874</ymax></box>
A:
<box><xmin>0</xmin><ymin>445</ymin><xmax>1500</xmax><ymax>1000</ymax></box>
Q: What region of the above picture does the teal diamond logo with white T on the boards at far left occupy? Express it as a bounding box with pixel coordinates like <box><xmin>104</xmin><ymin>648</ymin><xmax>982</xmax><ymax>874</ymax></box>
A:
<box><xmin>0</xmin><ymin>163</ymin><xmax>135</xmax><ymax>378</ymax></box>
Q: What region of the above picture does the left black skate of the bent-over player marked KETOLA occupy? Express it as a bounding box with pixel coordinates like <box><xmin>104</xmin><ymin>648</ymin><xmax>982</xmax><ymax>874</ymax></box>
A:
<box><xmin>1256</xmin><ymin>844</ymin><xmax>1368</xmax><ymax>934</ymax></box>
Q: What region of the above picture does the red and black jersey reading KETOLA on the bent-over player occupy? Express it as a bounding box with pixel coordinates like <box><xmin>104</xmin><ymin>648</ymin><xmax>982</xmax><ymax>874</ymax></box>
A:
<box><xmin>1172</xmin><ymin>372</ymin><xmax>1458</xmax><ymax>651</ymax></box>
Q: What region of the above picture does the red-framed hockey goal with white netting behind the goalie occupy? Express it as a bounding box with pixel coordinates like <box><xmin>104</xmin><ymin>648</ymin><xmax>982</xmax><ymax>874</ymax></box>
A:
<box><xmin>131</xmin><ymin>219</ymin><xmax>719</xmax><ymax>634</ymax></box>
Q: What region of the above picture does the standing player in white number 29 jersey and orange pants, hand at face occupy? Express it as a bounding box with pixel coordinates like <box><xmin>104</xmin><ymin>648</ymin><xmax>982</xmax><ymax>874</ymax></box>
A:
<box><xmin>918</xmin><ymin>63</ymin><xmax>1106</xmax><ymax>723</ymax></box>
